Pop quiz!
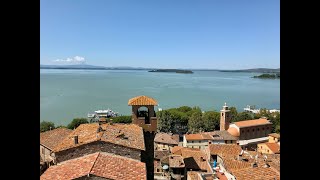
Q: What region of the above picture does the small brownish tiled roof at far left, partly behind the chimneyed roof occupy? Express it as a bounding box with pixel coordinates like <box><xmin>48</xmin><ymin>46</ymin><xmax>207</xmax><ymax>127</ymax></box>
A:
<box><xmin>40</xmin><ymin>128</ymin><xmax>72</xmax><ymax>150</ymax></box>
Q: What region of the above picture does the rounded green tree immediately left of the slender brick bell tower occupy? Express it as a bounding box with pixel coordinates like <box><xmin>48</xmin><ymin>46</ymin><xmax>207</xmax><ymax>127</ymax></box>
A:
<box><xmin>202</xmin><ymin>111</ymin><xmax>220</xmax><ymax>131</ymax></box>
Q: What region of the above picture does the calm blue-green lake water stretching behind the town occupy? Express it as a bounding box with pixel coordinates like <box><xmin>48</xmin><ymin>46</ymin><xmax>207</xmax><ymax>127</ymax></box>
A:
<box><xmin>40</xmin><ymin>69</ymin><xmax>280</xmax><ymax>125</ymax></box>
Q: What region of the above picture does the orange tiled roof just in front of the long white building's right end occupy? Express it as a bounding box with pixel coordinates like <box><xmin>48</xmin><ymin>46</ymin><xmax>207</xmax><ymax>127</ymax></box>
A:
<box><xmin>209</xmin><ymin>144</ymin><xmax>242</xmax><ymax>157</ymax></box>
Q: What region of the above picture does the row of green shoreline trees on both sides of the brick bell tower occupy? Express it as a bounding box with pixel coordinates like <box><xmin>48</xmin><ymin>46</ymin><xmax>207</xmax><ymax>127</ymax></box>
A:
<box><xmin>157</xmin><ymin>106</ymin><xmax>280</xmax><ymax>134</ymax></box>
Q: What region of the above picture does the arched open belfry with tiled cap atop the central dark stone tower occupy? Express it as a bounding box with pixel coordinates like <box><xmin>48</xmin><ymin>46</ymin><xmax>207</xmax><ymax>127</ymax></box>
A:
<box><xmin>128</xmin><ymin>96</ymin><xmax>158</xmax><ymax>133</ymax></box>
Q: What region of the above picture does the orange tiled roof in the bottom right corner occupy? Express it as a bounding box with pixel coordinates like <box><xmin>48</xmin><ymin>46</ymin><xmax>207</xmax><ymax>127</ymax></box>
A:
<box><xmin>232</xmin><ymin>167</ymin><xmax>280</xmax><ymax>180</ymax></box>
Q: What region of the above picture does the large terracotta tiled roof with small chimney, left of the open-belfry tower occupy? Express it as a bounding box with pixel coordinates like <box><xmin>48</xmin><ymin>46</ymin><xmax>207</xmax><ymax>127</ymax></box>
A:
<box><xmin>54</xmin><ymin>123</ymin><xmax>145</xmax><ymax>152</ymax></box>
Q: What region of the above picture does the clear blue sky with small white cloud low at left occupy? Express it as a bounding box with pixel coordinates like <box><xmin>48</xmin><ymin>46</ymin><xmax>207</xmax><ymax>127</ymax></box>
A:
<box><xmin>40</xmin><ymin>0</ymin><xmax>280</xmax><ymax>69</ymax></box>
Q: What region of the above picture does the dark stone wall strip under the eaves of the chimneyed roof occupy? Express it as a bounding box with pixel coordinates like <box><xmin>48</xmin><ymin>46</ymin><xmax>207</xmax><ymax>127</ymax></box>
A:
<box><xmin>55</xmin><ymin>141</ymin><xmax>141</xmax><ymax>163</ymax></box>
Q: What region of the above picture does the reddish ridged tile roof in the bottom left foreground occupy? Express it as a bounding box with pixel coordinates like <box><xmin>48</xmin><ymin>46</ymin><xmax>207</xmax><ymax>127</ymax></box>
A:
<box><xmin>40</xmin><ymin>152</ymin><xmax>146</xmax><ymax>180</ymax></box>
